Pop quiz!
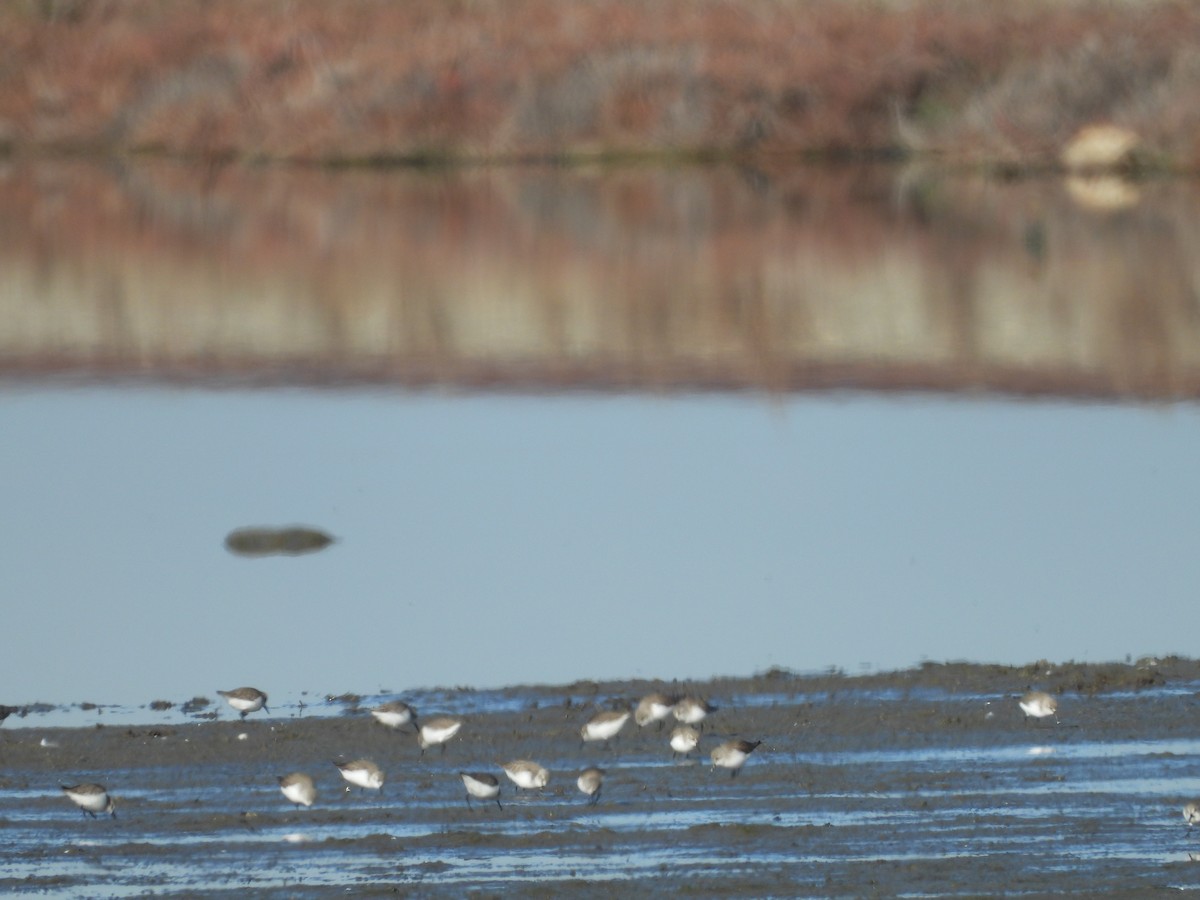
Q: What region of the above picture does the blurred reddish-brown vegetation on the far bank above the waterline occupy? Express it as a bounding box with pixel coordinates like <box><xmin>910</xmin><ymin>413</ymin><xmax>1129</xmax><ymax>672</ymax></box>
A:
<box><xmin>7</xmin><ymin>0</ymin><xmax>1200</xmax><ymax>168</ymax></box>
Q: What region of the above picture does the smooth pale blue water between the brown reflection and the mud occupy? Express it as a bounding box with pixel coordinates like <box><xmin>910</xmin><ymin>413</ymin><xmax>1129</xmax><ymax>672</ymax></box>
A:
<box><xmin>7</xmin><ymin>388</ymin><xmax>1200</xmax><ymax>704</ymax></box>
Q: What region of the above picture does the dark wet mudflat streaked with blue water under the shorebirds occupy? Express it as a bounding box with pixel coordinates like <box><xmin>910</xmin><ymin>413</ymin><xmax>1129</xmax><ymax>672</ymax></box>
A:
<box><xmin>7</xmin><ymin>659</ymin><xmax>1200</xmax><ymax>896</ymax></box>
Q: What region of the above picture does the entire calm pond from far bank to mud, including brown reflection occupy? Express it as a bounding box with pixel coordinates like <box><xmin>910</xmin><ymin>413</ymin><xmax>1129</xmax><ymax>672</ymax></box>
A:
<box><xmin>0</xmin><ymin>163</ymin><xmax>1200</xmax><ymax>710</ymax></box>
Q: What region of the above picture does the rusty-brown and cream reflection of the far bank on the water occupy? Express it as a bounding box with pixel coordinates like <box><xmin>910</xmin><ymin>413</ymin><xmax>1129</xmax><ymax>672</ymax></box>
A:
<box><xmin>9</xmin><ymin>161</ymin><xmax>1200</xmax><ymax>400</ymax></box>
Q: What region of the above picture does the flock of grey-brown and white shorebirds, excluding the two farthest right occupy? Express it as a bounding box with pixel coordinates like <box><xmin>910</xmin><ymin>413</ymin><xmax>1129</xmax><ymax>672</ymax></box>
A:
<box><xmin>54</xmin><ymin>688</ymin><xmax>762</xmax><ymax>818</ymax></box>
